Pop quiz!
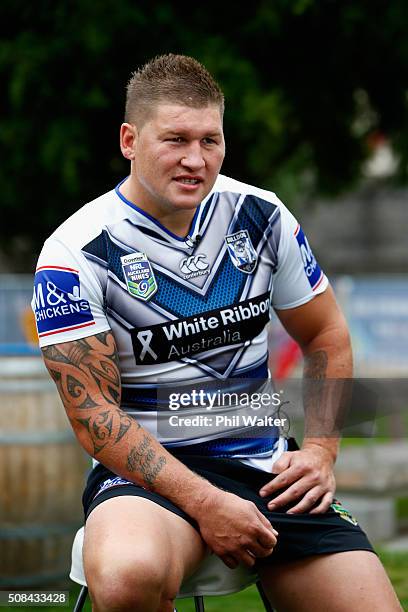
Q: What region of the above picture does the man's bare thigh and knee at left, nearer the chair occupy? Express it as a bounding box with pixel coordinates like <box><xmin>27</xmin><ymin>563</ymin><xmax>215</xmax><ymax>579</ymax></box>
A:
<box><xmin>83</xmin><ymin>495</ymin><xmax>206</xmax><ymax>594</ymax></box>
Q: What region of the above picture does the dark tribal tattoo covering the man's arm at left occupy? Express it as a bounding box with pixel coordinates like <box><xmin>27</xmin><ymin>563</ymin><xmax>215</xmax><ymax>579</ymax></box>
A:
<box><xmin>42</xmin><ymin>332</ymin><xmax>166</xmax><ymax>486</ymax></box>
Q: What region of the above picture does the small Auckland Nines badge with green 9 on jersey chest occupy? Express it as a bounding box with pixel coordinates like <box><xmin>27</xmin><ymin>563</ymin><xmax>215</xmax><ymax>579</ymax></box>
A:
<box><xmin>120</xmin><ymin>253</ymin><xmax>157</xmax><ymax>302</ymax></box>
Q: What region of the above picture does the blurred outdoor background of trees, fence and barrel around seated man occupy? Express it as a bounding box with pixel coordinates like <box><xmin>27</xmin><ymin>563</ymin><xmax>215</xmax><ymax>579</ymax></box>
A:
<box><xmin>0</xmin><ymin>0</ymin><xmax>408</xmax><ymax>610</ymax></box>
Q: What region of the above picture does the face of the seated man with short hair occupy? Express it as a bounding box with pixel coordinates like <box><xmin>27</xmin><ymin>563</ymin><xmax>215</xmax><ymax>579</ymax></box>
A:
<box><xmin>124</xmin><ymin>104</ymin><xmax>225</xmax><ymax>216</ymax></box>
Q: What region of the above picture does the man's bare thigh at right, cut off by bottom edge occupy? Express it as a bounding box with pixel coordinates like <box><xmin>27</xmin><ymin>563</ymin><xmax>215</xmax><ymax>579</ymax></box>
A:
<box><xmin>259</xmin><ymin>550</ymin><xmax>402</xmax><ymax>612</ymax></box>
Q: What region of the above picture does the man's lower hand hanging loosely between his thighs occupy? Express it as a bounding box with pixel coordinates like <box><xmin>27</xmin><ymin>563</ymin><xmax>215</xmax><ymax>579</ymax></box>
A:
<box><xmin>196</xmin><ymin>488</ymin><xmax>278</xmax><ymax>568</ymax></box>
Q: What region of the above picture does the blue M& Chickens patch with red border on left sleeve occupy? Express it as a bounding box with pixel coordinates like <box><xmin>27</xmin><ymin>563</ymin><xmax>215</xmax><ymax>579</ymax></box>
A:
<box><xmin>32</xmin><ymin>266</ymin><xmax>95</xmax><ymax>338</ymax></box>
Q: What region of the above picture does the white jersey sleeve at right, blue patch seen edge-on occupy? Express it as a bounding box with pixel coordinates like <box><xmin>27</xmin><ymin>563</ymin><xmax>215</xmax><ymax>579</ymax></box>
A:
<box><xmin>272</xmin><ymin>205</ymin><xmax>329</xmax><ymax>310</ymax></box>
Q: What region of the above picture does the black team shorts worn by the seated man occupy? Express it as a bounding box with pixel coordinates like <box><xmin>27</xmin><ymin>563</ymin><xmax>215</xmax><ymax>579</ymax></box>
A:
<box><xmin>82</xmin><ymin>440</ymin><xmax>374</xmax><ymax>564</ymax></box>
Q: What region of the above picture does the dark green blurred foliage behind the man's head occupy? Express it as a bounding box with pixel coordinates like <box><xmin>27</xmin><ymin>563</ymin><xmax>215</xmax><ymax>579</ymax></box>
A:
<box><xmin>0</xmin><ymin>0</ymin><xmax>408</xmax><ymax>265</ymax></box>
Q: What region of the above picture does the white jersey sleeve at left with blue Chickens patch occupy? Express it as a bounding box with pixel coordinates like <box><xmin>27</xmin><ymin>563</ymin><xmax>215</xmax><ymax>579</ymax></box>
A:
<box><xmin>31</xmin><ymin>237</ymin><xmax>110</xmax><ymax>347</ymax></box>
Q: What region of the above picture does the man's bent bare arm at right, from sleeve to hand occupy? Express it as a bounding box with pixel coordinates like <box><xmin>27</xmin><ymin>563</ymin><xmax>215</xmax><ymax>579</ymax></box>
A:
<box><xmin>261</xmin><ymin>286</ymin><xmax>353</xmax><ymax>514</ymax></box>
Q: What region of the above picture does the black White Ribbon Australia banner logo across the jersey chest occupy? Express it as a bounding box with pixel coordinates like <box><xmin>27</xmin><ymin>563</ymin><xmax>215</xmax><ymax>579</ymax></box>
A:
<box><xmin>131</xmin><ymin>293</ymin><xmax>270</xmax><ymax>365</ymax></box>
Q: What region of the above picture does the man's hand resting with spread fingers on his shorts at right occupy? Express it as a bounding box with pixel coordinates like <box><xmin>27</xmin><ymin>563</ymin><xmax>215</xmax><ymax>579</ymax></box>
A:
<box><xmin>259</xmin><ymin>444</ymin><xmax>336</xmax><ymax>514</ymax></box>
